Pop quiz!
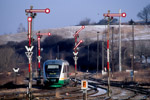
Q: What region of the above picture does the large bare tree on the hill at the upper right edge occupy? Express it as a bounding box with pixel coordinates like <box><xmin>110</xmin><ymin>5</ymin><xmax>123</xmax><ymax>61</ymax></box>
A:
<box><xmin>137</xmin><ymin>4</ymin><xmax>150</xmax><ymax>24</ymax></box>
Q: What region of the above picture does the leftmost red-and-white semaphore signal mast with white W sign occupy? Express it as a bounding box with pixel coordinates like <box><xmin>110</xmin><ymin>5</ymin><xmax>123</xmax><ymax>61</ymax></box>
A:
<box><xmin>25</xmin><ymin>6</ymin><xmax>50</xmax><ymax>100</ymax></box>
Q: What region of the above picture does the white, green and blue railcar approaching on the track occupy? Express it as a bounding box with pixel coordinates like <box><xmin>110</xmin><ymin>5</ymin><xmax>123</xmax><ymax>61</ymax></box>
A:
<box><xmin>43</xmin><ymin>60</ymin><xmax>69</xmax><ymax>87</ymax></box>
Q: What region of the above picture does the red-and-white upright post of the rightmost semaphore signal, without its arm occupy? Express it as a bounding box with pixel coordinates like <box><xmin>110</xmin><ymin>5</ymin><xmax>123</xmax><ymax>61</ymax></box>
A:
<box><xmin>107</xmin><ymin>10</ymin><xmax>110</xmax><ymax>96</ymax></box>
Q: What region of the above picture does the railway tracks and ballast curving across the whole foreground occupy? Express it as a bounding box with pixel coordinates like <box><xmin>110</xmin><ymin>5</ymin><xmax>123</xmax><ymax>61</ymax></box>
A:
<box><xmin>0</xmin><ymin>74</ymin><xmax>150</xmax><ymax>100</ymax></box>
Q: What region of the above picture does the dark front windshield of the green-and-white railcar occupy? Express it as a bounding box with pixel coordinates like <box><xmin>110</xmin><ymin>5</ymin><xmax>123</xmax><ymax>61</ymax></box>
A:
<box><xmin>45</xmin><ymin>65</ymin><xmax>61</xmax><ymax>77</ymax></box>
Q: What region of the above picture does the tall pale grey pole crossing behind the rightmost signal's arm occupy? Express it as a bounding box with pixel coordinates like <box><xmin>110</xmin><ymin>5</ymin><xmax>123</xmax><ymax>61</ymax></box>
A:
<box><xmin>119</xmin><ymin>9</ymin><xmax>122</xmax><ymax>72</ymax></box>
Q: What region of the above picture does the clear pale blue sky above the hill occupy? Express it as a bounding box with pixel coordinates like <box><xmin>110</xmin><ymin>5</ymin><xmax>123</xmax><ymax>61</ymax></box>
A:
<box><xmin>0</xmin><ymin>0</ymin><xmax>150</xmax><ymax>35</ymax></box>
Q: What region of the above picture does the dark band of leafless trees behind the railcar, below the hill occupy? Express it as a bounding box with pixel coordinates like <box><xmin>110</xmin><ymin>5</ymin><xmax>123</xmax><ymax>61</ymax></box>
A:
<box><xmin>0</xmin><ymin>35</ymin><xmax>150</xmax><ymax>72</ymax></box>
